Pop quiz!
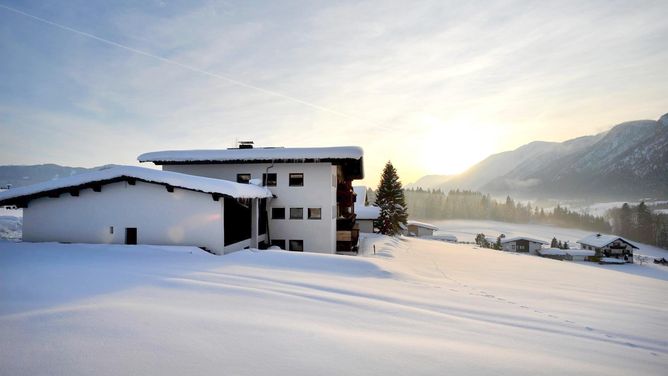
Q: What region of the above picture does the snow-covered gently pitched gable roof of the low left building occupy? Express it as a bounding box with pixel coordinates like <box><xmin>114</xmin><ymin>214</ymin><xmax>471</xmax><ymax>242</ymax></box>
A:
<box><xmin>0</xmin><ymin>166</ymin><xmax>272</xmax><ymax>204</ymax></box>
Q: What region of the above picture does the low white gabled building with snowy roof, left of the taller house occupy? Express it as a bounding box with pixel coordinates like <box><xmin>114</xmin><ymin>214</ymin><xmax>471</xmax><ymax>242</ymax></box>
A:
<box><xmin>0</xmin><ymin>166</ymin><xmax>272</xmax><ymax>254</ymax></box>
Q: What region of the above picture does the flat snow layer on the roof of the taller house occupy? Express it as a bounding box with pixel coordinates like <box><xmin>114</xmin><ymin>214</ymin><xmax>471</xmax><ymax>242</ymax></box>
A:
<box><xmin>137</xmin><ymin>146</ymin><xmax>364</xmax><ymax>164</ymax></box>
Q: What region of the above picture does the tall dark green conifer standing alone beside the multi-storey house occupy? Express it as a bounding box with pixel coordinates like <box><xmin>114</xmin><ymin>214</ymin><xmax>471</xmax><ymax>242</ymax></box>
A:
<box><xmin>376</xmin><ymin>161</ymin><xmax>408</xmax><ymax>235</ymax></box>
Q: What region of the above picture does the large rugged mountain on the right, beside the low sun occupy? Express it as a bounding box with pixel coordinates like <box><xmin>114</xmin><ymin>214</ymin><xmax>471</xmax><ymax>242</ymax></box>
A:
<box><xmin>413</xmin><ymin>114</ymin><xmax>668</xmax><ymax>199</ymax></box>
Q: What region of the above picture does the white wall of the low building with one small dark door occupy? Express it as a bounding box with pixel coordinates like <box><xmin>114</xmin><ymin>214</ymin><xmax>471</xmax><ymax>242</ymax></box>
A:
<box><xmin>23</xmin><ymin>181</ymin><xmax>237</xmax><ymax>253</ymax></box>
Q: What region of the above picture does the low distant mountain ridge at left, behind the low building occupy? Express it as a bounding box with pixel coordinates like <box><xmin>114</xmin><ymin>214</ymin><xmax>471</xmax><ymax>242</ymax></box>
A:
<box><xmin>0</xmin><ymin>164</ymin><xmax>118</xmax><ymax>188</ymax></box>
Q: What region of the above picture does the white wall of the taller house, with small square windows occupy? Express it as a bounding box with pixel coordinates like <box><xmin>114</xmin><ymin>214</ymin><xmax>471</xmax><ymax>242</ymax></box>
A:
<box><xmin>163</xmin><ymin>162</ymin><xmax>336</xmax><ymax>253</ymax></box>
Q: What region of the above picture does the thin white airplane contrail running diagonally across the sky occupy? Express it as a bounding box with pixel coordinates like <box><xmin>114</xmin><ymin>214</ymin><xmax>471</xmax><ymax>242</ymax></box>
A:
<box><xmin>0</xmin><ymin>4</ymin><xmax>382</xmax><ymax>126</ymax></box>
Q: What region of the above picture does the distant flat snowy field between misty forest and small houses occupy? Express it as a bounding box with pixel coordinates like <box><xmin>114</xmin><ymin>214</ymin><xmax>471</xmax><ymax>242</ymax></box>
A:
<box><xmin>430</xmin><ymin>220</ymin><xmax>668</xmax><ymax>258</ymax></box>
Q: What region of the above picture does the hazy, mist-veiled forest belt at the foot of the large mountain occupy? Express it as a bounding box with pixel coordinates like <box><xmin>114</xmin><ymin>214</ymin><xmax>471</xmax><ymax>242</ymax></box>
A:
<box><xmin>405</xmin><ymin>188</ymin><xmax>612</xmax><ymax>232</ymax></box>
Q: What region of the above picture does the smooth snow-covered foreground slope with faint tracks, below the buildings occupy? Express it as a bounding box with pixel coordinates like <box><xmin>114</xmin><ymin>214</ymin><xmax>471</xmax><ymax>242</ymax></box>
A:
<box><xmin>0</xmin><ymin>236</ymin><xmax>668</xmax><ymax>375</ymax></box>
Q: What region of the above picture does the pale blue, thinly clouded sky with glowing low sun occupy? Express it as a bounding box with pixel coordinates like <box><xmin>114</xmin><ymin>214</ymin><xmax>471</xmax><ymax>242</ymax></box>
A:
<box><xmin>0</xmin><ymin>0</ymin><xmax>668</xmax><ymax>186</ymax></box>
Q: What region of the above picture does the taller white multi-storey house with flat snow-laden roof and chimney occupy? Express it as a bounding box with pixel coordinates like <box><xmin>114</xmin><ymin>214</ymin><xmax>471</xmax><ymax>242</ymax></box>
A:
<box><xmin>138</xmin><ymin>143</ymin><xmax>364</xmax><ymax>253</ymax></box>
